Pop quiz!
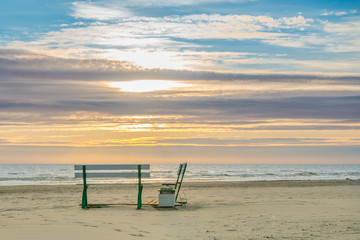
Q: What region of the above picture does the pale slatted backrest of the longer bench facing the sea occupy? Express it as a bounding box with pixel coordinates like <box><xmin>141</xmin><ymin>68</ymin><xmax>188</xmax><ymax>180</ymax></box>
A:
<box><xmin>74</xmin><ymin>164</ymin><xmax>150</xmax><ymax>178</ymax></box>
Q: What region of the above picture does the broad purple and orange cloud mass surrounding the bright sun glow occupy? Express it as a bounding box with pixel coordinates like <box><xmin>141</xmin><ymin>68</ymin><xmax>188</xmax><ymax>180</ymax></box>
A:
<box><xmin>0</xmin><ymin>48</ymin><xmax>360</xmax><ymax>150</ymax></box>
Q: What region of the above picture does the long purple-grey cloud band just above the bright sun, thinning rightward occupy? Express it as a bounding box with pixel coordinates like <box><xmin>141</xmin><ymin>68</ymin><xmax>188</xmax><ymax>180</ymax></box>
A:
<box><xmin>0</xmin><ymin>48</ymin><xmax>360</xmax><ymax>83</ymax></box>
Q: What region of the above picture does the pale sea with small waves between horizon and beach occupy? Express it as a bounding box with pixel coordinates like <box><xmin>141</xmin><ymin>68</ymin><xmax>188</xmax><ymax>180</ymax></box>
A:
<box><xmin>0</xmin><ymin>164</ymin><xmax>360</xmax><ymax>186</ymax></box>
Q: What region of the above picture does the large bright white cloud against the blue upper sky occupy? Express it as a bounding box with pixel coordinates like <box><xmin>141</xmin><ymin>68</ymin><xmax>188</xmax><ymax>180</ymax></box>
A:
<box><xmin>3</xmin><ymin>11</ymin><xmax>320</xmax><ymax>70</ymax></box>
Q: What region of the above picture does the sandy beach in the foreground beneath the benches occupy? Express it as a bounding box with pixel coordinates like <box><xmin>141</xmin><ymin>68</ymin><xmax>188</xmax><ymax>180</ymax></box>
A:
<box><xmin>0</xmin><ymin>180</ymin><xmax>360</xmax><ymax>240</ymax></box>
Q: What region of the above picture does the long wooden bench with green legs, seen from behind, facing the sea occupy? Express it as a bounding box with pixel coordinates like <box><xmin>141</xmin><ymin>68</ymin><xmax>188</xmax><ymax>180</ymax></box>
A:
<box><xmin>74</xmin><ymin>164</ymin><xmax>150</xmax><ymax>209</ymax></box>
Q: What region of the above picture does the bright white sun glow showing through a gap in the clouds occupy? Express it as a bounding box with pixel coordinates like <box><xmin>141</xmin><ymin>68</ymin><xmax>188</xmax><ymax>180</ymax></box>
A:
<box><xmin>108</xmin><ymin>80</ymin><xmax>190</xmax><ymax>93</ymax></box>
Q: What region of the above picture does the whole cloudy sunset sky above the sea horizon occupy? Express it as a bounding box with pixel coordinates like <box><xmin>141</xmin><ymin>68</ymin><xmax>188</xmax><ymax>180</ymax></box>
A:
<box><xmin>0</xmin><ymin>0</ymin><xmax>360</xmax><ymax>164</ymax></box>
